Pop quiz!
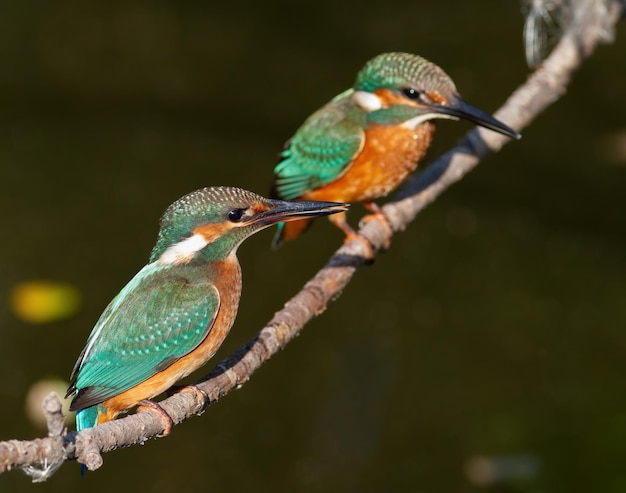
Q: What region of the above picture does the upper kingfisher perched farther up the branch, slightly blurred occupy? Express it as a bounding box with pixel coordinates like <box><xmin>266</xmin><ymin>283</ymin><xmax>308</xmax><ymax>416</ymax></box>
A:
<box><xmin>271</xmin><ymin>53</ymin><xmax>520</xmax><ymax>253</ymax></box>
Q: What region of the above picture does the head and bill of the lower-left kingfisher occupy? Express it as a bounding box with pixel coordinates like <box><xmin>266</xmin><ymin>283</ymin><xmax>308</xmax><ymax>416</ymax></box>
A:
<box><xmin>150</xmin><ymin>187</ymin><xmax>348</xmax><ymax>265</ymax></box>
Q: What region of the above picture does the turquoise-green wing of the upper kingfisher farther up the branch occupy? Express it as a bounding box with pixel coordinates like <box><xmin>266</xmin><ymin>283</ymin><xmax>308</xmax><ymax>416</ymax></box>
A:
<box><xmin>273</xmin><ymin>98</ymin><xmax>365</xmax><ymax>200</ymax></box>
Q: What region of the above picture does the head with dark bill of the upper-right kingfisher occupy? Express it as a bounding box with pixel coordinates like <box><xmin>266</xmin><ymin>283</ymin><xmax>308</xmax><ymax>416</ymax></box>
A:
<box><xmin>352</xmin><ymin>53</ymin><xmax>520</xmax><ymax>139</ymax></box>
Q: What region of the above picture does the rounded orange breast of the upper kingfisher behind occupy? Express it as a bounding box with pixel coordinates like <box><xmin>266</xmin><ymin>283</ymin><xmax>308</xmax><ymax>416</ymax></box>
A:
<box><xmin>302</xmin><ymin>122</ymin><xmax>435</xmax><ymax>203</ymax></box>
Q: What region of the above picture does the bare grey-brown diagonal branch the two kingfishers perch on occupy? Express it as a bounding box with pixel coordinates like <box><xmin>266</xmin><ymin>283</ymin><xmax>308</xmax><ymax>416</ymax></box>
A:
<box><xmin>0</xmin><ymin>0</ymin><xmax>622</xmax><ymax>482</ymax></box>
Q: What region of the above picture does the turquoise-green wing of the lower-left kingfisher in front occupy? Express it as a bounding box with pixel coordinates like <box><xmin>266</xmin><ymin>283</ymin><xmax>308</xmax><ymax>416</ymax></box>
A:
<box><xmin>68</xmin><ymin>264</ymin><xmax>220</xmax><ymax>410</ymax></box>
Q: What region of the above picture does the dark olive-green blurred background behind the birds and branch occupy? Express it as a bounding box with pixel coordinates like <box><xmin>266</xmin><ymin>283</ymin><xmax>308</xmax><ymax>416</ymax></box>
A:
<box><xmin>0</xmin><ymin>0</ymin><xmax>626</xmax><ymax>493</ymax></box>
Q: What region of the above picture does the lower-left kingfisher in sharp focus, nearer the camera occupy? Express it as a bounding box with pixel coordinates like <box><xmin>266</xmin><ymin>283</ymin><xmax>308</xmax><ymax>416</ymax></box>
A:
<box><xmin>66</xmin><ymin>187</ymin><xmax>347</xmax><ymax>434</ymax></box>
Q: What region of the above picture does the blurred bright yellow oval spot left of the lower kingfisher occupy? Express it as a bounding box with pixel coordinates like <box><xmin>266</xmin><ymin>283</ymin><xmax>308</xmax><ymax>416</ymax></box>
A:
<box><xmin>10</xmin><ymin>281</ymin><xmax>80</xmax><ymax>324</ymax></box>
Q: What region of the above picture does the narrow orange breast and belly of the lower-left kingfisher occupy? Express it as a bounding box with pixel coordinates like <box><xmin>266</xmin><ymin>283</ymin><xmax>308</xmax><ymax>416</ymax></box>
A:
<box><xmin>98</xmin><ymin>254</ymin><xmax>241</xmax><ymax>424</ymax></box>
